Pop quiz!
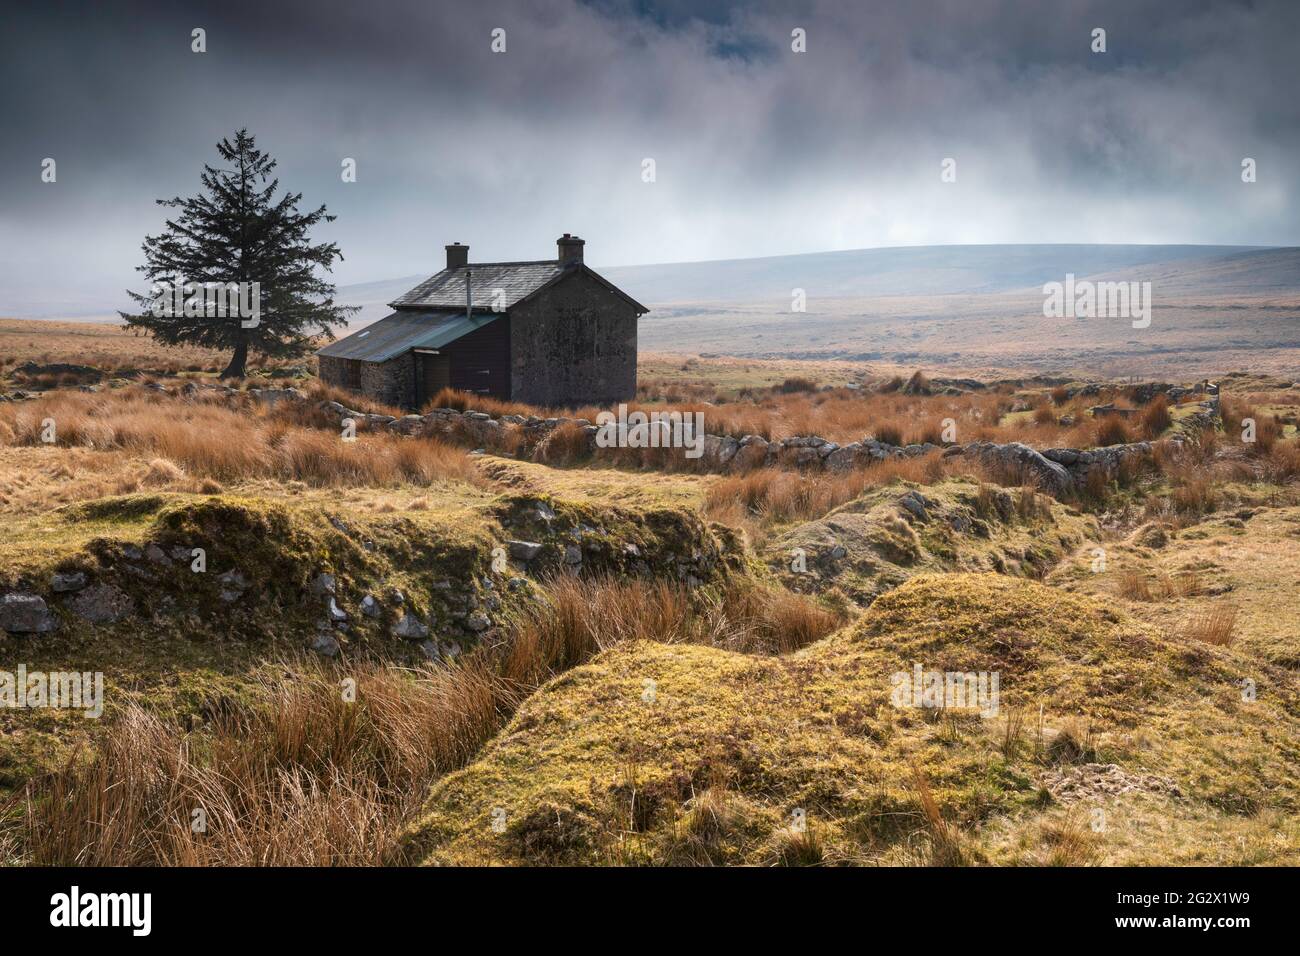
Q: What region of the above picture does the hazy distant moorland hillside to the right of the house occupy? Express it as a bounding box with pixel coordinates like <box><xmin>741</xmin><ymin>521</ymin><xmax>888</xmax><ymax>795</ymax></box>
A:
<box><xmin>606</xmin><ymin>246</ymin><xmax>1300</xmax><ymax>377</ymax></box>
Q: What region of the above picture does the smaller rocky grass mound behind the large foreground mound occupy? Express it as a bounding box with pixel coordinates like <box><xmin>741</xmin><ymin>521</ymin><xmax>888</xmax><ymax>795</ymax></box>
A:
<box><xmin>767</xmin><ymin>480</ymin><xmax>1097</xmax><ymax>604</ymax></box>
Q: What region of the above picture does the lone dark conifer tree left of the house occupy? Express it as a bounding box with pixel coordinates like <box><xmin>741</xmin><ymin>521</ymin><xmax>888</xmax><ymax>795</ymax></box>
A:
<box><xmin>120</xmin><ymin>130</ymin><xmax>358</xmax><ymax>378</ymax></box>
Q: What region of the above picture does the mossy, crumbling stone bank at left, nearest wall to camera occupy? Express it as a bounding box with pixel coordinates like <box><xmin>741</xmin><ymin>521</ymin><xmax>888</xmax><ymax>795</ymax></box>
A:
<box><xmin>0</xmin><ymin>455</ymin><xmax>746</xmax><ymax>663</ymax></box>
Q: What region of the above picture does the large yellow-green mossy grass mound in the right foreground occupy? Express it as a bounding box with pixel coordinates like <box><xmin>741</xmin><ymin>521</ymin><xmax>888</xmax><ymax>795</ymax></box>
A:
<box><xmin>404</xmin><ymin>574</ymin><xmax>1300</xmax><ymax>865</ymax></box>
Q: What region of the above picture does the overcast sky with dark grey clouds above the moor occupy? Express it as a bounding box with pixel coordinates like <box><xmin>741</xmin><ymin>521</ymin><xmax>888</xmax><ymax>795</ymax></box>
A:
<box><xmin>0</xmin><ymin>0</ymin><xmax>1300</xmax><ymax>315</ymax></box>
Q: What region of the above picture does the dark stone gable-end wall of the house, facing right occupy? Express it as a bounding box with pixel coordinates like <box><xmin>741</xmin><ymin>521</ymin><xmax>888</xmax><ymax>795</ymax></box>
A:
<box><xmin>510</xmin><ymin>272</ymin><xmax>637</xmax><ymax>407</ymax></box>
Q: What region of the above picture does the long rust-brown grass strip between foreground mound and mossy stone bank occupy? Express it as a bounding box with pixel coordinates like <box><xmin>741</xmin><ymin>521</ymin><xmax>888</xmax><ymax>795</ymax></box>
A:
<box><xmin>18</xmin><ymin>576</ymin><xmax>841</xmax><ymax>866</ymax></box>
